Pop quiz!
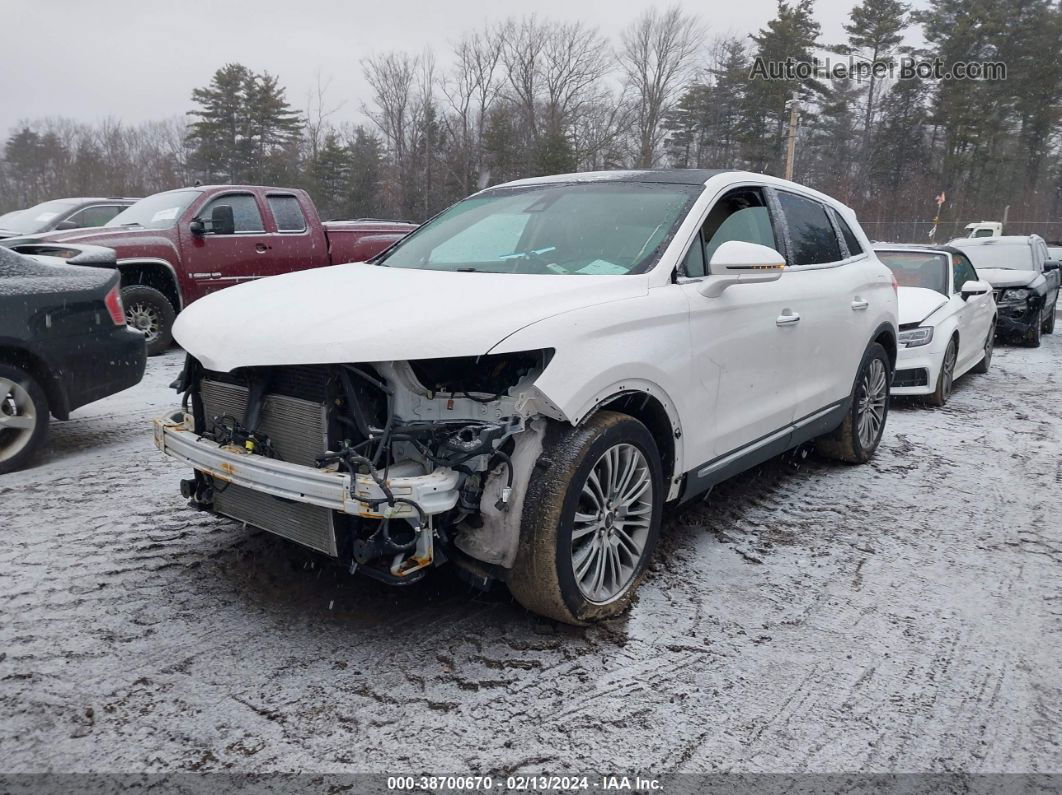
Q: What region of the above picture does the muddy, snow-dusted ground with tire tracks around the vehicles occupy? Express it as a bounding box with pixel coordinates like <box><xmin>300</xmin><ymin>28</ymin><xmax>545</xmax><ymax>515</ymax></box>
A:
<box><xmin>0</xmin><ymin>335</ymin><xmax>1062</xmax><ymax>775</ymax></box>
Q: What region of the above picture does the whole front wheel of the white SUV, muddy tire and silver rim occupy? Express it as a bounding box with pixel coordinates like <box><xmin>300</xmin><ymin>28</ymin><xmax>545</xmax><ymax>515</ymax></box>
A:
<box><xmin>509</xmin><ymin>411</ymin><xmax>665</xmax><ymax>624</ymax></box>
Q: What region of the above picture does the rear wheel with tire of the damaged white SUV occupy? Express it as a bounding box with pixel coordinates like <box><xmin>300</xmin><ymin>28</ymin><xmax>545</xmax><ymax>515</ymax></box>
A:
<box><xmin>816</xmin><ymin>343</ymin><xmax>892</xmax><ymax>464</ymax></box>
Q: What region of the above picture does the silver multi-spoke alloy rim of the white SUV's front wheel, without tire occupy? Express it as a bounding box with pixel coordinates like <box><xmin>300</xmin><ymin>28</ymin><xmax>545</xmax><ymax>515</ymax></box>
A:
<box><xmin>571</xmin><ymin>444</ymin><xmax>656</xmax><ymax>603</ymax></box>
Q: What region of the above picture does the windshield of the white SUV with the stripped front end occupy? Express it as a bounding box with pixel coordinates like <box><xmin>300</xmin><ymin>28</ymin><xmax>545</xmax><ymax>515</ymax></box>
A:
<box><xmin>378</xmin><ymin>182</ymin><xmax>703</xmax><ymax>276</ymax></box>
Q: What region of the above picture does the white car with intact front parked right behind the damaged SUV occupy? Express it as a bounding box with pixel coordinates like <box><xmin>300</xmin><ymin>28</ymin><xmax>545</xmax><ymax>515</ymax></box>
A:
<box><xmin>874</xmin><ymin>244</ymin><xmax>996</xmax><ymax>405</ymax></box>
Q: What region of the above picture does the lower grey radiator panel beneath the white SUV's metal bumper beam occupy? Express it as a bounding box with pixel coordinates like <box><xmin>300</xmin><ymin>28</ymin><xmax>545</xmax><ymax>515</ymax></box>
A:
<box><xmin>213</xmin><ymin>484</ymin><xmax>337</xmax><ymax>557</ymax></box>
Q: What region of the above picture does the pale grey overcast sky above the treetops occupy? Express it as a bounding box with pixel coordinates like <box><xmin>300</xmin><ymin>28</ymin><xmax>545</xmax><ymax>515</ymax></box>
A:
<box><xmin>0</xmin><ymin>0</ymin><xmax>921</xmax><ymax>137</ymax></box>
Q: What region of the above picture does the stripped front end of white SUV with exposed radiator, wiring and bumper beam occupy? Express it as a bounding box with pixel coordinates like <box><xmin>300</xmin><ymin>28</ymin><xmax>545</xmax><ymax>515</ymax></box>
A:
<box><xmin>155</xmin><ymin>349</ymin><xmax>556</xmax><ymax>584</ymax></box>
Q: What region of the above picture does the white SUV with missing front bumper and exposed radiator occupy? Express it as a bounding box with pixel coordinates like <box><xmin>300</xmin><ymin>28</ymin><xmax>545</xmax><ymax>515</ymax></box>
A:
<box><xmin>155</xmin><ymin>170</ymin><xmax>897</xmax><ymax>623</ymax></box>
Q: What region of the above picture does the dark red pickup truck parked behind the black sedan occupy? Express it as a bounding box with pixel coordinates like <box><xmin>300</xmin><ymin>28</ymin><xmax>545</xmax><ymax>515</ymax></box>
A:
<box><xmin>14</xmin><ymin>185</ymin><xmax>416</xmax><ymax>355</ymax></box>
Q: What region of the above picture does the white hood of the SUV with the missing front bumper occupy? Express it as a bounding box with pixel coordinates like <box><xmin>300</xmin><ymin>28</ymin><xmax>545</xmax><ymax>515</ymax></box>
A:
<box><xmin>173</xmin><ymin>263</ymin><xmax>649</xmax><ymax>371</ymax></box>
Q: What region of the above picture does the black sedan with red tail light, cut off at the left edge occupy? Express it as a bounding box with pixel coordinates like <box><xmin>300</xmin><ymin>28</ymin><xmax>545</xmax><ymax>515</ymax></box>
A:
<box><xmin>0</xmin><ymin>246</ymin><xmax>147</xmax><ymax>474</ymax></box>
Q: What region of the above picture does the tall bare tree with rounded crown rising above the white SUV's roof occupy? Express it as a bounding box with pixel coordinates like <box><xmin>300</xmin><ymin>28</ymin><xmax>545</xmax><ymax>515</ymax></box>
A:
<box><xmin>619</xmin><ymin>5</ymin><xmax>704</xmax><ymax>168</ymax></box>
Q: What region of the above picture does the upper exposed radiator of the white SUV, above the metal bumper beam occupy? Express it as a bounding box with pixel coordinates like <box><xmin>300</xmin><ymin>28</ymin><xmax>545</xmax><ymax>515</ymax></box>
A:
<box><xmin>201</xmin><ymin>380</ymin><xmax>328</xmax><ymax>466</ymax></box>
